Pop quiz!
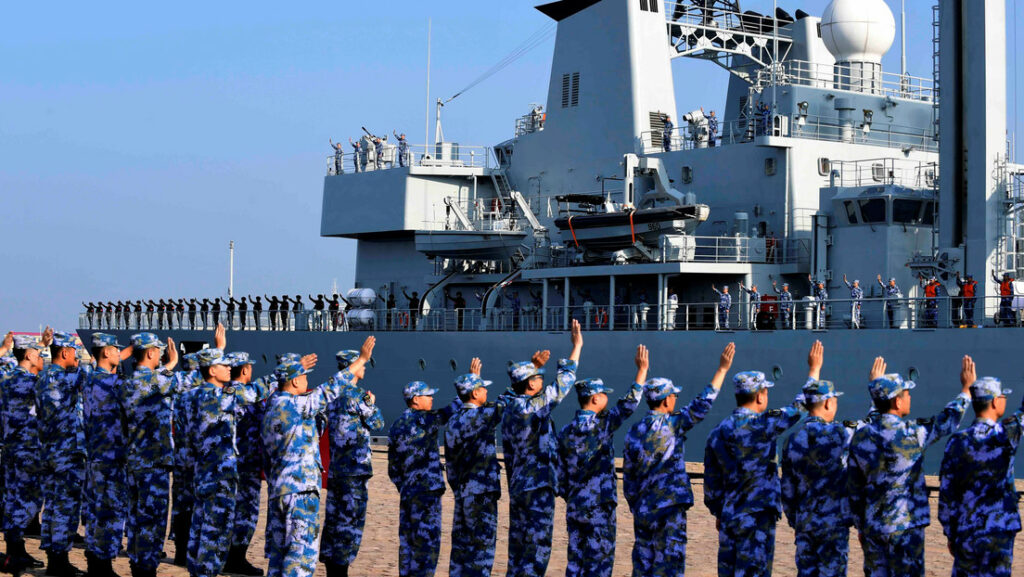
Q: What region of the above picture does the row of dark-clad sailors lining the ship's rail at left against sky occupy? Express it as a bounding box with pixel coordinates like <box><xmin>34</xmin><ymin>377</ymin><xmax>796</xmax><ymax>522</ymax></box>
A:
<box><xmin>82</xmin><ymin>294</ymin><xmax>350</xmax><ymax>331</ymax></box>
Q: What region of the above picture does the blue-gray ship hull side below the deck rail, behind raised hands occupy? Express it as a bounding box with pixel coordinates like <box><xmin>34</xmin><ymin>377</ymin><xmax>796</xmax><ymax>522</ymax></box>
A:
<box><xmin>79</xmin><ymin>328</ymin><xmax>1024</xmax><ymax>478</ymax></box>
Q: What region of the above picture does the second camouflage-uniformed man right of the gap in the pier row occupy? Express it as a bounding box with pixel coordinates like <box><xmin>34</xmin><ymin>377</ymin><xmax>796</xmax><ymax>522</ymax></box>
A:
<box><xmin>444</xmin><ymin>371</ymin><xmax>509</xmax><ymax>577</ymax></box>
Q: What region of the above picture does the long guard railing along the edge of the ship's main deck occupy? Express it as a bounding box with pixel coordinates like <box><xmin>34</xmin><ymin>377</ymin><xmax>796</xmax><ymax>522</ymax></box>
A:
<box><xmin>79</xmin><ymin>289</ymin><xmax>1024</xmax><ymax>332</ymax></box>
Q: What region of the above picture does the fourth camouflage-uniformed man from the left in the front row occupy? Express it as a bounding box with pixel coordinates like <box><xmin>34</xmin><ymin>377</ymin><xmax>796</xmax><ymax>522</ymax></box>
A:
<box><xmin>120</xmin><ymin>333</ymin><xmax>195</xmax><ymax>577</ymax></box>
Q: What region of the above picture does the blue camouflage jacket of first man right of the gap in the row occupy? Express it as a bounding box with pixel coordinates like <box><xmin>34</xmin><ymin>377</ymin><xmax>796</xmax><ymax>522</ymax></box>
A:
<box><xmin>387</xmin><ymin>398</ymin><xmax>462</xmax><ymax>496</ymax></box>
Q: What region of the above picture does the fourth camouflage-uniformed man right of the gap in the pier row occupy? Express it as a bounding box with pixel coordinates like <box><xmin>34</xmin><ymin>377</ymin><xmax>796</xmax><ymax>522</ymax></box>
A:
<box><xmin>558</xmin><ymin>344</ymin><xmax>648</xmax><ymax>577</ymax></box>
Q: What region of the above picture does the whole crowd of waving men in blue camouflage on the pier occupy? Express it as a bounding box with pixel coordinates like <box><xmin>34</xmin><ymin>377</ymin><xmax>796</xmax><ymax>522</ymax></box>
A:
<box><xmin>0</xmin><ymin>319</ymin><xmax>1024</xmax><ymax>577</ymax></box>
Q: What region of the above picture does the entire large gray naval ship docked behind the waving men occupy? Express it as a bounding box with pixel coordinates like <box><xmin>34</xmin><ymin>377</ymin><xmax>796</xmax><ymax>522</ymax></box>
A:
<box><xmin>80</xmin><ymin>0</ymin><xmax>1024</xmax><ymax>477</ymax></box>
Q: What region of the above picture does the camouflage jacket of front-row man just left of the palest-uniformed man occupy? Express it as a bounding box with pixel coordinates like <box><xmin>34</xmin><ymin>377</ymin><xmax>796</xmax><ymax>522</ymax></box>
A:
<box><xmin>181</xmin><ymin>380</ymin><xmax>267</xmax><ymax>497</ymax></box>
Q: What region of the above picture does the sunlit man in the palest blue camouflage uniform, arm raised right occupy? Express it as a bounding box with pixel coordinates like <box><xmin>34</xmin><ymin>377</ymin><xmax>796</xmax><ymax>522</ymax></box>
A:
<box><xmin>260</xmin><ymin>336</ymin><xmax>376</xmax><ymax>577</ymax></box>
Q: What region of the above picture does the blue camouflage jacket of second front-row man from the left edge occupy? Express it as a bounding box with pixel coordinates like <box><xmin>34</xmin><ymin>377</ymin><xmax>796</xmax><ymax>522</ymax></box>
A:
<box><xmin>36</xmin><ymin>364</ymin><xmax>92</xmax><ymax>466</ymax></box>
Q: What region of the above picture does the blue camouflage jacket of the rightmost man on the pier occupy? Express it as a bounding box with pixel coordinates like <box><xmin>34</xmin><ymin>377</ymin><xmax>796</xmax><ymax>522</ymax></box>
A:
<box><xmin>939</xmin><ymin>397</ymin><xmax>1024</xmax><ymax>541</ymax></box>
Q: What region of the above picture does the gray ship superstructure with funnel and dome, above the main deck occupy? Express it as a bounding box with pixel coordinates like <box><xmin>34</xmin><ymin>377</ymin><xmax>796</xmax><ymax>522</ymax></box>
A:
<box><xmin>322</xmin><ymin>0</ymin><xmax>1020</xmax><ymax>329</ymax></box>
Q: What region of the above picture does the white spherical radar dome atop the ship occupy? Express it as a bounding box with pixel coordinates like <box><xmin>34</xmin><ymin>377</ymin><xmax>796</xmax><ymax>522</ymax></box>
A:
<box><xmin>821</xmin><ymin>0</ymin><xmax>896</xmax><ymax>64</ymax></box>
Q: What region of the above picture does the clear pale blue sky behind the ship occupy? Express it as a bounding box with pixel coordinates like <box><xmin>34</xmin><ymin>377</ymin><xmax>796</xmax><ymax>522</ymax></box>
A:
<box><xmin>0</xmin><ymin>0</ymin><xmax>1024</xmax><ymax>330</ymax></box>
